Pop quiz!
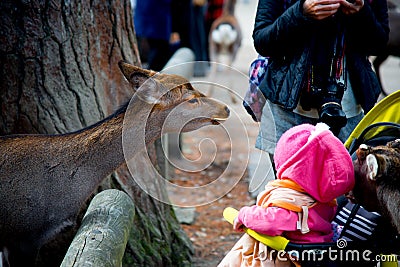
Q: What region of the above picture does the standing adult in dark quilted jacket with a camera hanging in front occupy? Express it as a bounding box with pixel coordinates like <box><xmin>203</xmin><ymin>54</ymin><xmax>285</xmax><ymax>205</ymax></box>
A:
<box><xmin>253</xmin><ymin>0</ymin><xmax>389</xmax><ymax>168</ymax></box>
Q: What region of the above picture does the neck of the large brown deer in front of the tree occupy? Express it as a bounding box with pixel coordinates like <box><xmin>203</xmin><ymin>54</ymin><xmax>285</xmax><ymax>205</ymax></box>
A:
<box><xmin>76</xmin><ymin>97</ymin><xmax>160</xmax><ymax>181</ymax></box>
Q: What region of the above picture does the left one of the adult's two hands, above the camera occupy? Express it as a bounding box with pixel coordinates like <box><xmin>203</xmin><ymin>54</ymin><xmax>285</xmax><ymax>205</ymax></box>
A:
<box><xmin>303</xmin><ymin>0</ymin><xmax>344</xmax><ymax>20</ymax></box>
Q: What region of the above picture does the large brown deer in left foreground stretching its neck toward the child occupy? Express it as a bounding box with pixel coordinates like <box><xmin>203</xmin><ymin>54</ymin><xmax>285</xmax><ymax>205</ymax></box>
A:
<box><xmin>0</xmin><ymin>61</ymin><xmax>229</xmax><ymax>266</ymax></box>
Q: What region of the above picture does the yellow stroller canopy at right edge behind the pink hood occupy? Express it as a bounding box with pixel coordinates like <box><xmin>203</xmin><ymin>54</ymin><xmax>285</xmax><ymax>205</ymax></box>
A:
<box><xmin>344</xmin><ymin>90</ymin><xmax>400</xmax><ymax>149</ymax></box>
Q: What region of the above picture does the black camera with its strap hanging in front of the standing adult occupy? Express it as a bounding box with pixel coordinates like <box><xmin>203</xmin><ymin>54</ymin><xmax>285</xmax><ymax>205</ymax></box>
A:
<box><xmin>300</xmin><ymin>13</ymin><xmax>347</xmax><ymax>135</ymax></box>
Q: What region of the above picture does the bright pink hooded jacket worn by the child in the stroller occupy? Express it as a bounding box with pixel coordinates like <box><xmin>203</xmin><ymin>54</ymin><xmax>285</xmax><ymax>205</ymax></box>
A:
<box><xmin>238</xmin><ymin>123</ymin><xmax>354</xmax><ymax>243</ymax></box>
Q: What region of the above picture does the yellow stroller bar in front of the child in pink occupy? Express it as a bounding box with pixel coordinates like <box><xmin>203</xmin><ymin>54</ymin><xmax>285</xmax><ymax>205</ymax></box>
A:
<box><xmin>223</xmin><ymin>207</ymin><xmax>289</xmax><ymax>251</ymax></box>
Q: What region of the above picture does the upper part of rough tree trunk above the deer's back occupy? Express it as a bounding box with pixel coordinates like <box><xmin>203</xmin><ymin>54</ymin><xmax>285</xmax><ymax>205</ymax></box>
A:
<box><xmin>0</xmin><ymin>0</ymin><xmax>138</xmax><ymax>134</ymax></box>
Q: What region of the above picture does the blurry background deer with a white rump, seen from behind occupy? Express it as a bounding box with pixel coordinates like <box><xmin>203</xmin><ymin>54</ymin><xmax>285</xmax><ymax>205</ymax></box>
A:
<box><xmin>207</xmin><ymin>0</ymin><xmax>242</xmax><ymax>103</ymax></box>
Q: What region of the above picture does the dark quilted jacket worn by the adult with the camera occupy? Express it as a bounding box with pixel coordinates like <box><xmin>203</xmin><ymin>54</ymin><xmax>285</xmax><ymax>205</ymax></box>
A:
<box><xmin>253</xmin><ymin>0</ymin><xmax>389</xmax><ymax>113</ymax></box>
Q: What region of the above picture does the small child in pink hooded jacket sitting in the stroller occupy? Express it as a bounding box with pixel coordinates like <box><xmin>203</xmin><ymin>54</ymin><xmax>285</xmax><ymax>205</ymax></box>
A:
<box><xmin>219</xmin><ymin>123</ymin><xmax>354</xmax><ymax>266</ymax></box>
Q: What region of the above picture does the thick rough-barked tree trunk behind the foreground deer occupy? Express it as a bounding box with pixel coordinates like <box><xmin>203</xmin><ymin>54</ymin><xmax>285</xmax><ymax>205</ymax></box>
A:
<box><xmin>0</xmin><ymin>0</ymin><xmax>192</xmax><ymax>266</ymax></box>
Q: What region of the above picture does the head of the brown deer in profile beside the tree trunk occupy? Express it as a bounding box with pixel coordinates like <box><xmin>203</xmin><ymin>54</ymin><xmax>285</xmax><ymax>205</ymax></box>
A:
<box><xmin>119</xmin><ymin>61</ymin><xmax>229</xmax><ymax>138</ymax></box>
